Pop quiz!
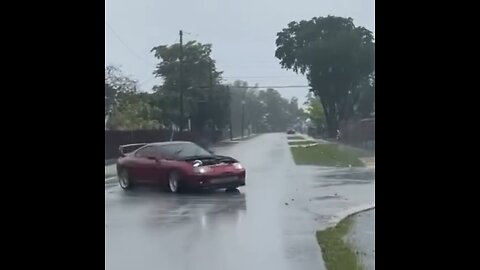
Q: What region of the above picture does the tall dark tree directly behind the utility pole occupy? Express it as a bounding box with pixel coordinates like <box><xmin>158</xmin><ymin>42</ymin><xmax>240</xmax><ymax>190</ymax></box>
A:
<box><xmin>151</xmin><ymin>41</ymin><xmax>229</xmax><ymax>130</ymax></box>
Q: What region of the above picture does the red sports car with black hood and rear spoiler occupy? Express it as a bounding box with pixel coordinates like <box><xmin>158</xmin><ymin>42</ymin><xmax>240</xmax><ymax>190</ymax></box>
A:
<box><xmin>117</xmin><ymin>141</ymin><xmax>245</xmax><ymax>193</ymax></box>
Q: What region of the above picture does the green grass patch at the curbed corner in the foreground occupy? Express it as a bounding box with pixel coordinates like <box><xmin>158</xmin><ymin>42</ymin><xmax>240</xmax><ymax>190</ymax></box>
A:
<box><xmin>317</xmin><ymin>216</ymin><xmax>364</xmax><ymax>270</ymax></box>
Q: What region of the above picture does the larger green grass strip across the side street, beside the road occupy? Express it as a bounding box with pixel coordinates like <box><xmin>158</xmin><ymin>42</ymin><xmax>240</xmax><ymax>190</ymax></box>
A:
<box><xmin>290</xmin><ymin>144</ymin><xmax>364</xmax><ymax>167</ymax></box>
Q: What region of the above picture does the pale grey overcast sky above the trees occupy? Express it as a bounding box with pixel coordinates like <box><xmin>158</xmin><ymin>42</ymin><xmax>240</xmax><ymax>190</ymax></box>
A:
<box><xmin>105</xmin><ymin>0</ymin><xmax>375</xmax><ymax>104</ymax></box>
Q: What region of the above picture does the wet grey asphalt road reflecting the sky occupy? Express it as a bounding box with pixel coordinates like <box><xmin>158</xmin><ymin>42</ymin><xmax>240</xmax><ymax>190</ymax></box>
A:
<box><xmin>105</xmin><ymin>133</ymin><xmax>375</xmax><ymax>270</ymax></box>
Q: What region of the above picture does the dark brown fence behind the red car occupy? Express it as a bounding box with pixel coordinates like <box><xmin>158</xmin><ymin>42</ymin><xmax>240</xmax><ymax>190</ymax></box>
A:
<box><xmin>105</xmin><ymin>129</ymin><xmax>223</xmax><ymax>160</ymax></box>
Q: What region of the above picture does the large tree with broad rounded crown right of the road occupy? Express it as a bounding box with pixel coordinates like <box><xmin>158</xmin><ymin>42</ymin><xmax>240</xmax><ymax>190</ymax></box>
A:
<box><xmin>275</xmin><ymin>16</ymin><xmax>375</xmax><ymax>136</ymax></box>
